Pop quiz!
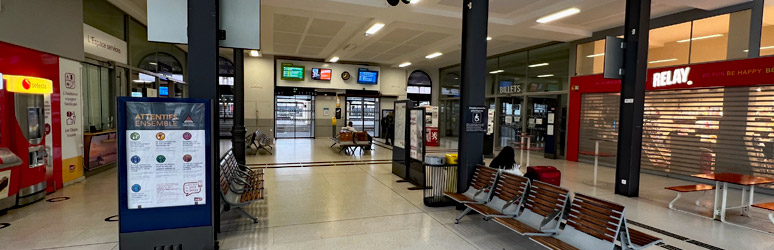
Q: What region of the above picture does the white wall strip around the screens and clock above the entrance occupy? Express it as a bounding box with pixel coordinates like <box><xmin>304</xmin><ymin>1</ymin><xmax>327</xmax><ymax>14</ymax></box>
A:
<box><xmin>275</xmin><ymin>60</ymin><xmax>385</xmax><ymax>91</ymax></box>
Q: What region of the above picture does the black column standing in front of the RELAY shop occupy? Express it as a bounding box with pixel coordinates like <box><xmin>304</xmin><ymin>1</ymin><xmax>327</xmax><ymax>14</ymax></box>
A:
<box><xmin>615</xmin><ymin>0</ymin><xmax>650</xmax><ymax>197</ymax></box>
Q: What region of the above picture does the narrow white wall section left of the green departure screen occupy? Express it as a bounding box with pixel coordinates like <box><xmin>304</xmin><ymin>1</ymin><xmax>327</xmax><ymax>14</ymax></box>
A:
<box><xmin>245</xmin><ymin>55</ymin><xmax>274</xmax><ymax>136</ymax></box>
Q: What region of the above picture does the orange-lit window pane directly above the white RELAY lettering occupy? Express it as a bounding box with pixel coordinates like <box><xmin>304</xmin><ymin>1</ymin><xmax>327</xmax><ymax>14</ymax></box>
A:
<box><xmin>648</xmin><ymin>22</ymin><xmax>691</xmax><ymax>68</ymax></box>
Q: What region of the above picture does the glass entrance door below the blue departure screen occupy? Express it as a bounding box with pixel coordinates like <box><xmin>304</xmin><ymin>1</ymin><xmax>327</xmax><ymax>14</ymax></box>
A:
<box><xmin>347</xmin><ymin>97</ymin><xmax>379</xmax><ymax>137</ymax></box>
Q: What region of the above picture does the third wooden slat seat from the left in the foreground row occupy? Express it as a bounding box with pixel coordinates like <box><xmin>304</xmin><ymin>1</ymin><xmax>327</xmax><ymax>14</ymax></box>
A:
<box><xmin>494</xmin><ymin>181</ymin><xmax>570</xmax><ymax>236</ymax></box>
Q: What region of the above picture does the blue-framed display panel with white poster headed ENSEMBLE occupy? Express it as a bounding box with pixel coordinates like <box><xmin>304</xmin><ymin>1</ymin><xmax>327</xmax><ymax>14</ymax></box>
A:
<box><xmin>118</xmin><ymin>98</ymin><xmax>212</xmax><ymax>233</ymax></box>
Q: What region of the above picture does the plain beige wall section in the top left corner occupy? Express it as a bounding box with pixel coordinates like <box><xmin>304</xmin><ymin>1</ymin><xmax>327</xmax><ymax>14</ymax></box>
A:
<box><xmin>0</xmin><ymin>0</ymin><xmax>83</xmax><ymax>61</ymax></box>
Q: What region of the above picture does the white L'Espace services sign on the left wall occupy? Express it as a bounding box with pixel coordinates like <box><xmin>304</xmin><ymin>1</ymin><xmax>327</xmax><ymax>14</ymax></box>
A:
<box><xmin>83</xmin><ymin>24</ymin><xmax>127</xmax><ymax>64</ymax></box>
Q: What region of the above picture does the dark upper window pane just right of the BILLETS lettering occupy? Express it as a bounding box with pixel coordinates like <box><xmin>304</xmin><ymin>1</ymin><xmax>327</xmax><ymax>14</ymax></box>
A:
<box><xmin>525</xmin><ymin>43</ymin><xmax>570</xmax><ymax>92</ymax></box>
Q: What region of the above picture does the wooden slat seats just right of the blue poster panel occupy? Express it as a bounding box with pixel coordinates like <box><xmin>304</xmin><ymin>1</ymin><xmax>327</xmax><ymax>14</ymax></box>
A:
<box><xmin>219</xmin><ymin>150</ymin><xmax>264</xmax><ymax>223</ymax></box>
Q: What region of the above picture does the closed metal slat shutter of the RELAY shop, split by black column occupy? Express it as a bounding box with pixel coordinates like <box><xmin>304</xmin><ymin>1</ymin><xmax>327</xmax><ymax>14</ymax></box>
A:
<box><xmin>579</xmin><ymin>86</ymin><xmax>774</xmax><ymax>184</ymax></box>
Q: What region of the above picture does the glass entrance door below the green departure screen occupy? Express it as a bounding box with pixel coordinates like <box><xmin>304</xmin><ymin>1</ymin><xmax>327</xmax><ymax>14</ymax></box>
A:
<box><xmin>274</xmin><ymin>95</ymin><xmax>314</xmax><ymax>139</ymax></box>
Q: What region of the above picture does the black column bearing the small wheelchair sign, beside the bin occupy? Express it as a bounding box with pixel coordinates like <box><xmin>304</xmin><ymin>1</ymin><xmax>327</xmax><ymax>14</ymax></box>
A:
<box><xmin>457</xmin><ymin>0</ymin><xmax>489</xmax><ymax>192</ymax></box>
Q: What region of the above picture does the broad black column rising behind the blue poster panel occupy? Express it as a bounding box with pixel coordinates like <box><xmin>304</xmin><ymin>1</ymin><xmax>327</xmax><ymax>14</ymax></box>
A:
<box><xmin>188</xmin><ymin>0</ymin><xmax>220</xmax><ymax>234</ymax></box>
